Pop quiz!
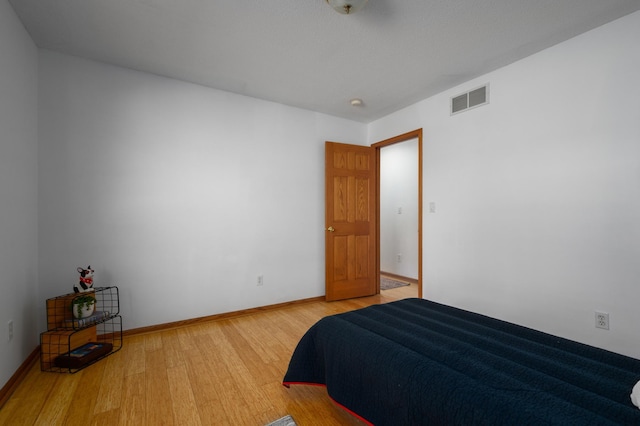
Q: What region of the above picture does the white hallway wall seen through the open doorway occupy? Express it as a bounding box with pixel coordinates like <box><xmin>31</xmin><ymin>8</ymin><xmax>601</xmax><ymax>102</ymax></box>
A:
<box><xmin>380</xmin><ymin>139</ymin><xmax>418</xmax><ymax>279</ymax></box>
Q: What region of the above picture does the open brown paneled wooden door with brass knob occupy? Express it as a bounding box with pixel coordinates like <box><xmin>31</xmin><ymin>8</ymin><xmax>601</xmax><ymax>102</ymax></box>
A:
<box><xmin>325</xmin><ymin>142</ymin><xmax>378</xmax><ymax>301</ymax></box>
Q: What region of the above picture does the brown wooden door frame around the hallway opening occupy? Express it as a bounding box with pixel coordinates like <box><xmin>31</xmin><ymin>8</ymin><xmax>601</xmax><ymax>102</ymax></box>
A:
<box><xmin>371</xmin><ymin>128</ymin><xmax>422</xmax><ymax>299</ymax></box>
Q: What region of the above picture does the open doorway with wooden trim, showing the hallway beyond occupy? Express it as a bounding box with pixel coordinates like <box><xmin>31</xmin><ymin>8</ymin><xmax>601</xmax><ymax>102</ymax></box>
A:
<box><xmin>372</xmin><ymin>129</ymin><xmax>422</xmax><ymax>298</ymax></box>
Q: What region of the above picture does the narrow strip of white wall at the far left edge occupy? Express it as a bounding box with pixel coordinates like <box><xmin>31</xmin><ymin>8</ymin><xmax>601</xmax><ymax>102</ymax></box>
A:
<box><xmin>0</xmin><ymin>1</ymin><xmax>39</xmax><ymax>387</ymax></box>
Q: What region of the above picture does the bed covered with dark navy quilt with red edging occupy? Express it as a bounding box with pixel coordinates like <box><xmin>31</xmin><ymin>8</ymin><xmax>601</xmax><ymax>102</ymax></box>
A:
<box><xmin>283</xmin><ymin>299</ymin><xmax>640</xmax><ymax>426</ymax></box>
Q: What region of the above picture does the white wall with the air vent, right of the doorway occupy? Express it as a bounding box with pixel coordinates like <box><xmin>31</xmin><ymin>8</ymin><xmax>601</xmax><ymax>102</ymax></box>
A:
<box><xmin>369</xmin><ymin>12</ymin><xmax>640</xmax><ymax>357</ymax></box>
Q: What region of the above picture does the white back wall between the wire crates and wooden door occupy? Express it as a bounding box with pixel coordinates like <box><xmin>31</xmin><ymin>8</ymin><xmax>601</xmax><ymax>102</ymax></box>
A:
<box><xmin>39</xmin><ymin>51</ymin><xmax>366</xmax><ymax>329</ymax></box>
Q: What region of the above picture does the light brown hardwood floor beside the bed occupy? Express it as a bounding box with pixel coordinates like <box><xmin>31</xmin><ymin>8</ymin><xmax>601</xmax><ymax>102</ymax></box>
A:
<box><xmin>0</xmin><ymin>284</ymin><xmax>417</xmax><ymax>426</ymax></box>
